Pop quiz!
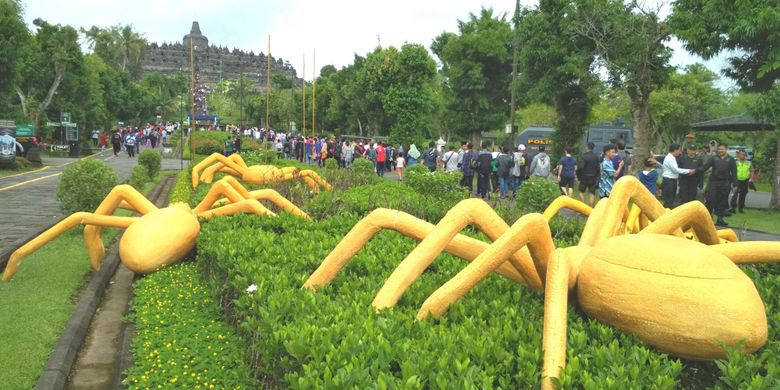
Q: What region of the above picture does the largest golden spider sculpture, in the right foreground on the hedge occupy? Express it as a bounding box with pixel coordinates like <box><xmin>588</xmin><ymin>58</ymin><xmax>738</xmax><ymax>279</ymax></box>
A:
<box><xmin>304</xmin><ymin>176</ymin><xmax>780</xmax><ymax>389</ymax></box>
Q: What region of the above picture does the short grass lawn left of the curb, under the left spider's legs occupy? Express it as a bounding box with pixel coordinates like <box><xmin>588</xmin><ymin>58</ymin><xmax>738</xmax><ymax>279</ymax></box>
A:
<box><xmin>0</xmin><ymin>176</ymin><xmax>160</xmax><ymax>389</ymax></box>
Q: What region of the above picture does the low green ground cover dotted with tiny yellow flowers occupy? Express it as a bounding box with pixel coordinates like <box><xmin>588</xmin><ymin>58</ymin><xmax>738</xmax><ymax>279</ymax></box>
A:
<box><xmin>123</xmin><ymin>262</ymin><xmax>254</xmax><ymax>389</ymax></box>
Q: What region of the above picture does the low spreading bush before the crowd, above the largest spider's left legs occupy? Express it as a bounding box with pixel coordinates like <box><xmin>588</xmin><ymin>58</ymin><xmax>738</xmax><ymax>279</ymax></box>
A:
<box><xmin>404</xmin><ymin>164</ymin><xmax>468</xmax><ymax>202</ymax></box>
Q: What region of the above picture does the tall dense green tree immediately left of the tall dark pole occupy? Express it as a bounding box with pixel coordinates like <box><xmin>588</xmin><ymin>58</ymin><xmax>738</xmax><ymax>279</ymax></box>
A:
<box><xmin>431</xmin><ymin>8</ymin><xmax>512</xmax><ymax>141</ymax></box>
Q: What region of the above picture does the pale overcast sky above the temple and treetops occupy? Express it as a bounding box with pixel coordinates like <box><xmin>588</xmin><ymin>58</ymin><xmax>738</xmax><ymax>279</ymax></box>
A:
<box><xmin>22</xmin><ymin>0</ymin><xmax>730</xmax><ymax>87</ymax></box>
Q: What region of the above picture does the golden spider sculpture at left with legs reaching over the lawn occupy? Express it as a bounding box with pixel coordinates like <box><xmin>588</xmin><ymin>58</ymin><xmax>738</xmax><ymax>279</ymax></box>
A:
<box><xmin>3</xmin><ymin>176</ymin><xmax>311</xmax><ymax>281</ymax></box>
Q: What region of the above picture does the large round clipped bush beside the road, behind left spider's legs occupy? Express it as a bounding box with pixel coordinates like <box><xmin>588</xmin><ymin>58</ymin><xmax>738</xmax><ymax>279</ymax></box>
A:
<box><xmin>57</xmin><ymin>159</ymin><xmax>119</xmax><ymax>213</ymax></box>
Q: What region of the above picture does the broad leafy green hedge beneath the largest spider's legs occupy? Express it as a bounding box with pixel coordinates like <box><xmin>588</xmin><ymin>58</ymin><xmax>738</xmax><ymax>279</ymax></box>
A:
<box><xmin>193</xmin><ymin>215</ymin><xmax>696</xmax><ymax>389</ymax></box>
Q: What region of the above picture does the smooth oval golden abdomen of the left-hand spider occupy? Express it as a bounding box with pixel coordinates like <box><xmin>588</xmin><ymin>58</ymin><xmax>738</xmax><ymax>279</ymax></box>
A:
<box><xmin>119</xmin><ymin>204</ymin><xmax>200</xmax><ymax>274</ymax></box>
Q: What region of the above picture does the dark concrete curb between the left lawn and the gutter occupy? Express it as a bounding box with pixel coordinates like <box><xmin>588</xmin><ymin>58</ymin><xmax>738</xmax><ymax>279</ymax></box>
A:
<box><xmin>35</xmin><ymin>243</ymin><xmax>119</xmax><ymax>390</ymax></box>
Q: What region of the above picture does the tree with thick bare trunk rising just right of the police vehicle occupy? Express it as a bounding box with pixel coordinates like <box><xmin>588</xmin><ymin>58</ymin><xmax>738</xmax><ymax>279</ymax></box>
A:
<box><xmin>577</xmin><ymin>0</ymin><xmax>671</xmax><ymax>169</ymax></box>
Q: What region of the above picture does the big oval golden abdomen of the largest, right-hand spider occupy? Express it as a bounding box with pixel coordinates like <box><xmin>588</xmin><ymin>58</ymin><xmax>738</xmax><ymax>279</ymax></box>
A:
<box><xmin>577</xmin><ymin>234</ymin><xmax>767</xmax><ymax>359</ymax></box>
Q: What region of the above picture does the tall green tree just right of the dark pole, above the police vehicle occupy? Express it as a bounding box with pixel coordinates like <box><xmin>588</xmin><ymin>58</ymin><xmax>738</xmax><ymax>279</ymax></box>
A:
<box><xmin>515</xmin><ymin>0</ymin><xmax>598</xmax><ymax>155</ymax></box>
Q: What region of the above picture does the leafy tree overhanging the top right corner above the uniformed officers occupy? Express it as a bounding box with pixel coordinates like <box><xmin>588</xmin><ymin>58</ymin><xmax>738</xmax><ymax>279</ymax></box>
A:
<box><xmin>670</xmin><ymin>0</ymin><xmax>780</xmax><ymax>208</ymax></box>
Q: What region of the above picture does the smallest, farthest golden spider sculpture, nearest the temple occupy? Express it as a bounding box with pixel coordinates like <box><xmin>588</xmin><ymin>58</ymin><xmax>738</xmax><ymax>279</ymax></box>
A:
<box><xmin>192</xmin><ymin>153</ymin><xmax>333</xmax><ymax>192</ymax></box>
